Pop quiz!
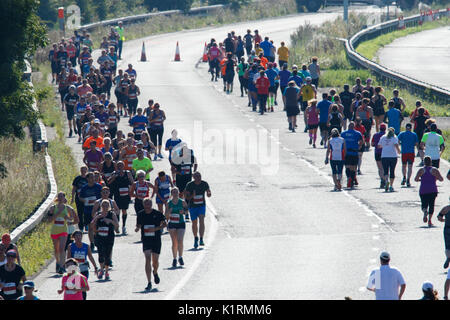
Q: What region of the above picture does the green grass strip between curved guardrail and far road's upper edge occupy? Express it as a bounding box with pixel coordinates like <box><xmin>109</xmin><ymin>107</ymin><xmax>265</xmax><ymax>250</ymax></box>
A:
<box><xmin>356</xmin><ymin>18</ymin><xmax>450</xmax><ymax>60</ymax></box>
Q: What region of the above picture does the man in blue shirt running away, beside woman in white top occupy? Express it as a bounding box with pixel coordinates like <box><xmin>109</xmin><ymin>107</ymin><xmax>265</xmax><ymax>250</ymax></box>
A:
<box><xmin>341</xmin><ymin>121</ymin><xmax>363</xmax><ymax>188</ymax></box>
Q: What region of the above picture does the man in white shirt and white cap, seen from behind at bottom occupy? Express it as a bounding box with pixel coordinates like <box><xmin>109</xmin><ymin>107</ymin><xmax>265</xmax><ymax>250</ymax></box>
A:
<box><xmin>367</xmin><ymin>252</ymin><xmax>406</xmax><ymax>300</ymax></box>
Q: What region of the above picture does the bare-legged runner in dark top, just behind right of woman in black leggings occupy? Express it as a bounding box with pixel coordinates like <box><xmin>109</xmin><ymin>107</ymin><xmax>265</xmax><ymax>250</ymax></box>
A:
<box><xmin>108</xmin><ymin>161</ymin><xmax>134</xmax><ymax>235</ymax></box>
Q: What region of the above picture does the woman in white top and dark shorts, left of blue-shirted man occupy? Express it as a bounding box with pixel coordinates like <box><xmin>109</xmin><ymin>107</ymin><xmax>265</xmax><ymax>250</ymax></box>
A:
<box><xmin>325</xmin><ymin>128</ymin><xmax>346</xmax><ymax>191</ymax></box>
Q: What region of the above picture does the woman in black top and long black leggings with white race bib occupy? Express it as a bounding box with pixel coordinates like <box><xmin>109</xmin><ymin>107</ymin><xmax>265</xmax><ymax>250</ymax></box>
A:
<box><xmin>90</xmin><ymin>199</ymin><xmax>119</xmax><ymax>281</ymax></box>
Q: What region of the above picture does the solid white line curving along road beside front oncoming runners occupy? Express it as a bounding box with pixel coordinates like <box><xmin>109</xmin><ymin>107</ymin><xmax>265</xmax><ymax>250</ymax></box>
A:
<box><xmin>164</xmin><ymin>200</ymin><xmax>219</xmax><ymax>300</ymax></box>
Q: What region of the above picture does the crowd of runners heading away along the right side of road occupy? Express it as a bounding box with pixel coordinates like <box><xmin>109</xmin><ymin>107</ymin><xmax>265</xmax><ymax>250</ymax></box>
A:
<box><xmin>207</xmin><ymin>30</ymin><xmax>450</xmax><ymax>298</ymax></box>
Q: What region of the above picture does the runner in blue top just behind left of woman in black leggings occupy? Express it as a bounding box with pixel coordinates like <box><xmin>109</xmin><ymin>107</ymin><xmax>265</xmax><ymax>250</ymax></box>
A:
<box><xmin>80</xmin><ymin>172</ymin><xmax>102</xmax><ymax>251</ymax></box>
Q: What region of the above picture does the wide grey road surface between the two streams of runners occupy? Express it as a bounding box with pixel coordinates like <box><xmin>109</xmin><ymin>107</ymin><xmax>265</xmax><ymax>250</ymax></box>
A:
<box><xmin>36</xmin><ymin>6</ymin><xmax>450</xmax><ymax>299</ymax></box>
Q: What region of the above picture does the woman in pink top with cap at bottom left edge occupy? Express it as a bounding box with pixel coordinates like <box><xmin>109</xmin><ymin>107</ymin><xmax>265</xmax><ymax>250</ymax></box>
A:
<box><xmin>58</xmin><ymin>258</ymin><xmax>89</xmax><ymax>300</ymax></box>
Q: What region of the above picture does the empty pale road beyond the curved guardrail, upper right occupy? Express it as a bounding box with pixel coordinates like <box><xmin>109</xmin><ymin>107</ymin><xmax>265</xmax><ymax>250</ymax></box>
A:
<box><xmin>378</xmin><ymin>26</ymin><xmax>450</xmax><ymax>90</ymax></box>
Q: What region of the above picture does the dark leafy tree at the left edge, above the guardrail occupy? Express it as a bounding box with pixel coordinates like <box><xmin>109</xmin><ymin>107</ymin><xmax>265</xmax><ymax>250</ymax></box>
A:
<box><xmin>0</xmin><ymin>0</ymin><xmax>47</xmax><ymax>138</ymax></box>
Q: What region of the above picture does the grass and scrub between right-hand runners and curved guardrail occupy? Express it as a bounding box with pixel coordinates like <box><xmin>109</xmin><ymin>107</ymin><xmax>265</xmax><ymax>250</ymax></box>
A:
<box><xmin>289</xmin><ymin>13</ymin><xmax>450</xmax><ymax>116</ymax></box>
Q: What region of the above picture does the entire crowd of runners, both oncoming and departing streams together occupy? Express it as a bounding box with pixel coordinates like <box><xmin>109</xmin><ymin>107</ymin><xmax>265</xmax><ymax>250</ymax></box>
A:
<box><xmin>0</xmin><ymin>24</ymin><xmax>450</xmax><ymax>300</ymax></box>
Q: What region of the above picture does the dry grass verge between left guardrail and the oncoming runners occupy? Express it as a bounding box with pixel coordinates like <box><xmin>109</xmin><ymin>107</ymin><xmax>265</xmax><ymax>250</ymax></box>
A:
<box><xmin>14</xmin><ymin>65</ymin><xmax>78</xmax><ymax>277</ymax></box>
